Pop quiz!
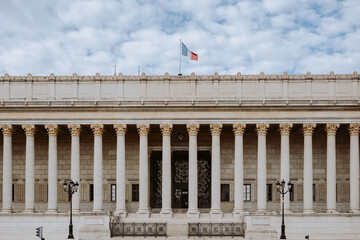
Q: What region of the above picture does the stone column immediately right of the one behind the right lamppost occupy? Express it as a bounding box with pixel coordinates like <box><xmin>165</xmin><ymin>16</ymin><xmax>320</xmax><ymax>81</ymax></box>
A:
<box><xmin>303</xmin><ymin>123</ymin><xmax>316</xmax><ymax>214</ymax></box>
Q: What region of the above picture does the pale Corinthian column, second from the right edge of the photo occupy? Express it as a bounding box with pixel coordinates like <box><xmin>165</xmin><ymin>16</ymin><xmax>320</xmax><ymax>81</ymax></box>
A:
<box><xmin>326</xmin><ymin>123</ymin><xmax>339</xmax><ymax>213</ymax></box>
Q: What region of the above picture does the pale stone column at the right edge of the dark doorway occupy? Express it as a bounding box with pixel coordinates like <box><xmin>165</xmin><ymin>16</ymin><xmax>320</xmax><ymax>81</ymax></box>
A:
<box><xmin>210</xmin><ymin>124</ymin><xmax>223</xmax><ymax>218</ymax></box>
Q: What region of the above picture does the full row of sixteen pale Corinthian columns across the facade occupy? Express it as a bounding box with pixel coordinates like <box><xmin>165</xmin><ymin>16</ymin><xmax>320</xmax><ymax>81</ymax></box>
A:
<box><xmin>1</xmin><ymin>123</ymin><xmax>360</xmax><ymax>218</ymax></box>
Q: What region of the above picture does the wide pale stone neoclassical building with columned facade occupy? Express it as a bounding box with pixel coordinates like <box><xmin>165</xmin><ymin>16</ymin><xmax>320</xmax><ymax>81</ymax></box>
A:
<box><xmin>0</xmin><ymin>72</ymin><xmax>360</xmax><ymax>239</ymax></box>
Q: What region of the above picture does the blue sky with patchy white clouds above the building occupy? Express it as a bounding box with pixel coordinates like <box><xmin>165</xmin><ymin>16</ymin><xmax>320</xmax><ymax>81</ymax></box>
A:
<box><xmin>0</xmin><ymin>0</ymin><xmax>360</xmax><ymax>75</ymax></box>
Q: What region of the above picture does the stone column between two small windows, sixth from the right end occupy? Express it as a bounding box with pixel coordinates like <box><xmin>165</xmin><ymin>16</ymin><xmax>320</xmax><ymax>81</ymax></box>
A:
<box><xmin>233</xmin><ymin>123</ymin><xmax>246</xmax><ymax>218</ymax></box>
